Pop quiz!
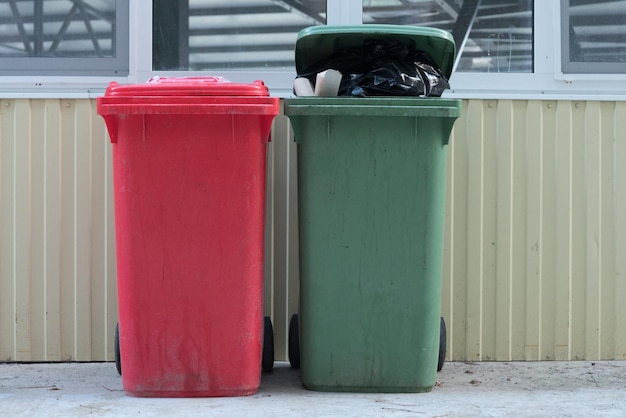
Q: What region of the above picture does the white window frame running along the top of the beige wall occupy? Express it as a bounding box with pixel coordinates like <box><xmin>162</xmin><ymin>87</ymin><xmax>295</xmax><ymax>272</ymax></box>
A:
<box><xmin>0</xmin><ymin>0</ymin><xmax>626</xmax><ymax>100</ymax></box>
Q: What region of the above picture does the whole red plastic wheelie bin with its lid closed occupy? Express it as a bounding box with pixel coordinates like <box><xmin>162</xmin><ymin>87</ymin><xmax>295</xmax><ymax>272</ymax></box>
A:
<box><xmin>98</xmin><ymin>76</ymin><xmax>278</xmax><ymax>397</ymax></box>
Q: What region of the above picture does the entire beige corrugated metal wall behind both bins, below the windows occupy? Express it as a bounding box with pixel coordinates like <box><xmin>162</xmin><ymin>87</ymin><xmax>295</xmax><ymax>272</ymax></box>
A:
<box><xmin>0</xmin><ymin>99</ymin><xmax>626</xmax><ymax>361</ymax></box>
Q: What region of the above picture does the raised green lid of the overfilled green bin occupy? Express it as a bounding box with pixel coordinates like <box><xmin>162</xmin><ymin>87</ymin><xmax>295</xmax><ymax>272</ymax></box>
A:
<box><xmin>296</xmin><ymin>24</ymin><xmax>456</xmax><ymax>78</ymax></box>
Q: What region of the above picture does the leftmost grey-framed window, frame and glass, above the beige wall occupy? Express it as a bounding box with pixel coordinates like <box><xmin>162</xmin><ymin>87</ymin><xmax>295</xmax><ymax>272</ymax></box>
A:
<box><xmin>0</xmin><ymin>0</ymin><xmax>129</xmax><ymax>75</ymax></box>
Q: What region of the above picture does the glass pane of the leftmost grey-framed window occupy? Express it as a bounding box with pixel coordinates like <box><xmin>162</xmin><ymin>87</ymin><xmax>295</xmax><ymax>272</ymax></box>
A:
<box><xmin>0</xmin><ymin>0</ymin><xmax>116</xmax><ymax>58</ymax></box>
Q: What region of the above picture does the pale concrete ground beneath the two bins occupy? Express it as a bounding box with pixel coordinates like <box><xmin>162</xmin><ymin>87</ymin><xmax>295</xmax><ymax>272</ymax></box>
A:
<box><xmin>0</xmin><ymin>361</ymin><xmax>626</xmax><ymax>418</ymax></box>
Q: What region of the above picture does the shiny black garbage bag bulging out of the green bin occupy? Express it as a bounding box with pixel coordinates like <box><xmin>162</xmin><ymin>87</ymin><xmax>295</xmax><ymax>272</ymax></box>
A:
<box><xmin>298</xmin><ymin>39</ymin><xmax>450</xmax><ymax>97</ymax></box>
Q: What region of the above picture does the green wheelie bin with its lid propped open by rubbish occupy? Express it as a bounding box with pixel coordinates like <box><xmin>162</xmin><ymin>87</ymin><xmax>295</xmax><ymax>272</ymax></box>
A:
<box><xmin>284</xmin><ymin>25</ymin><xmax>461</xmax><ymax>392</ymax></box>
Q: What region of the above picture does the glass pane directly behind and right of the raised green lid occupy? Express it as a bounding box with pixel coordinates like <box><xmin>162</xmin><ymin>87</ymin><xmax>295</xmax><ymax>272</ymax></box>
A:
<box><xmin>363</xmin><ymin>0</ymin><xmax>533</xmax><ymax>72</ymax></box>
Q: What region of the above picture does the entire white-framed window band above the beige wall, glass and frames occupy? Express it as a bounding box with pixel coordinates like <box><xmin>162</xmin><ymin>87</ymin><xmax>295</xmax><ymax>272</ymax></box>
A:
<box><xmin>0</xmin><ymin>0</ymin><xmax>626</xmax><ymax>100</ymax></box>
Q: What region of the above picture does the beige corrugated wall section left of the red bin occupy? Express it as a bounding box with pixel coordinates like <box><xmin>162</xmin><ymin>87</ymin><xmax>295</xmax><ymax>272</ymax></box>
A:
<box><xmin>0</xmin><ymin>99</ymin><xmax>117</xmax><ymax>361</ymax></box>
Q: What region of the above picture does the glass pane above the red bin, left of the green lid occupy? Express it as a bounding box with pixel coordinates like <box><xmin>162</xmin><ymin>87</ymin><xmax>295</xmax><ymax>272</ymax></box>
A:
<box><xmin>152</xmin><ymin>0</ymin><xmax>326</xmax><ymax>71</ymax></box>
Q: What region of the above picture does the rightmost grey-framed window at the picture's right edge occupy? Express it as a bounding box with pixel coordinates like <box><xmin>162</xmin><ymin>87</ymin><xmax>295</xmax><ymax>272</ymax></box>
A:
<box><xmin>561</xmin><ymin>0</ymin><xmax>626</xmax><ymax>74</ymax></box>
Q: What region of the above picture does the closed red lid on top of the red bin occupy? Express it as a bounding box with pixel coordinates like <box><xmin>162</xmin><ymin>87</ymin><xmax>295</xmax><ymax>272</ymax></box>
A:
<box><xmin>105</xmin><ymin>76</ymin><xmax>269</xmax><ymax>97</ymax></box>
